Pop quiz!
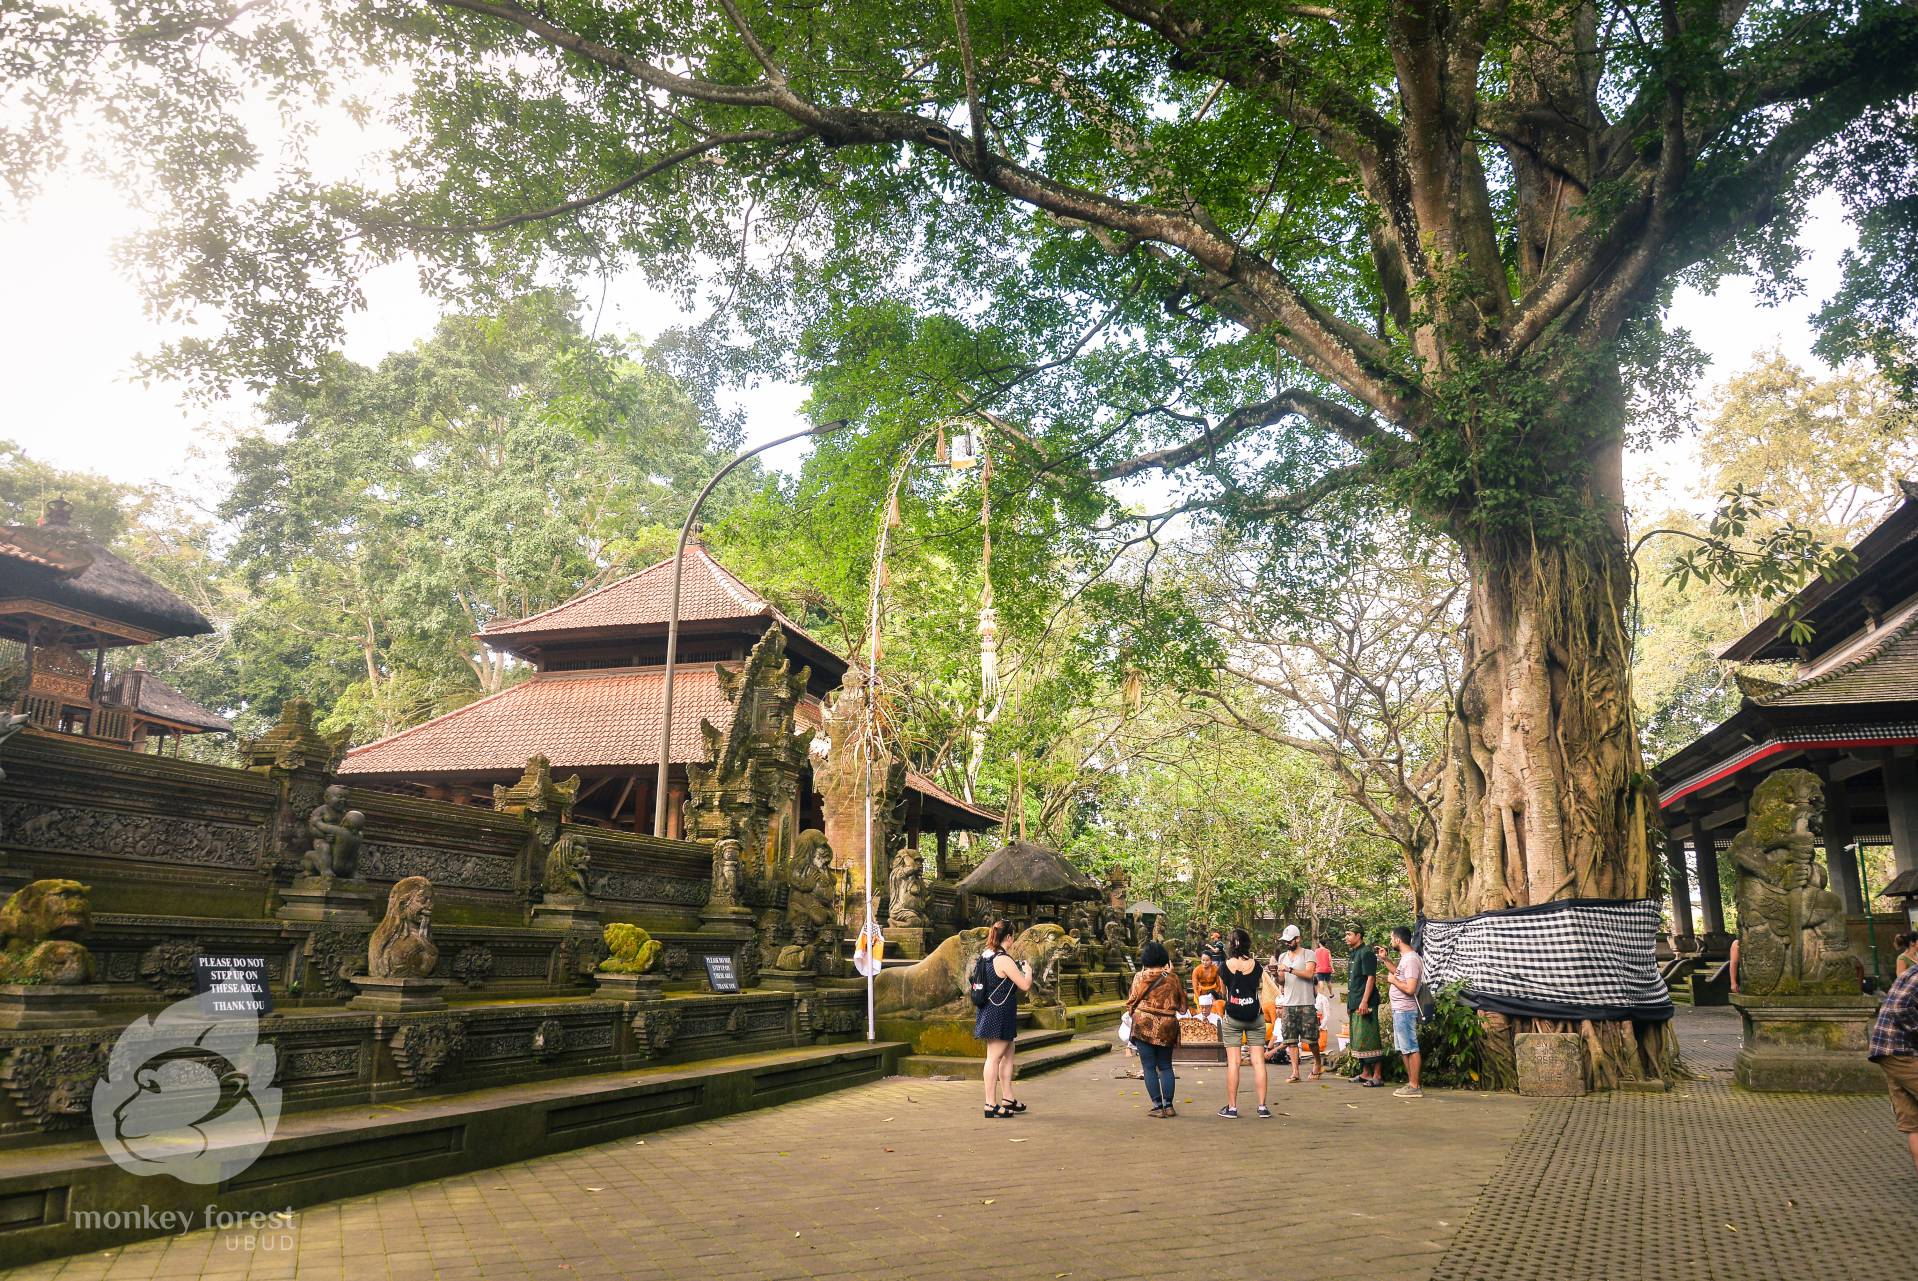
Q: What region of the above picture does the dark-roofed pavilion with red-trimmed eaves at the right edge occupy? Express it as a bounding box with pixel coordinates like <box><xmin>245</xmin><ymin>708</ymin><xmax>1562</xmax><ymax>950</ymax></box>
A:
<box><xmin>1653</xmin><ymin>481</ymin><xmax>1918</xmax><ymax>970</ymax></box>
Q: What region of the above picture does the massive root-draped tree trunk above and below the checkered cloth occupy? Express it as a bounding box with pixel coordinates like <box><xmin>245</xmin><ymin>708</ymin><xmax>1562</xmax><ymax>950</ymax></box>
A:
<box><xmin>1419</xmin><ymin>387</ymin><xmax>1674</xmax><ymax>1087</ymax></box>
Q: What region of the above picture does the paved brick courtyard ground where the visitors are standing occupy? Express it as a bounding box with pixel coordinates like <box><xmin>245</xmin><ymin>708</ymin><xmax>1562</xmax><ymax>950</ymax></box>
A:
<box><xmin>13</xmin><ymin>1013</ymin><xmax>1918</xmax><ymax>1281</ymax></box>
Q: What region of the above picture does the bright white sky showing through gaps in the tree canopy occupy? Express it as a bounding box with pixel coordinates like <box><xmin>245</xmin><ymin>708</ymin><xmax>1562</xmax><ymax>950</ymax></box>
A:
<box><xmin>0</xmin><ymin>160</ymin><xmax>1855</xmax><ymax>502</ymax></box>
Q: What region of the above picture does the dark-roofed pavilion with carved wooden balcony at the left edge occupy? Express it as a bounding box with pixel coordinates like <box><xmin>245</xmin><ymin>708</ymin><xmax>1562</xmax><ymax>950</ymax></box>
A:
<box><xmin>0</xmin><ymin>499</ymin><xmax>232</xmax><ymax>752</ymax></box>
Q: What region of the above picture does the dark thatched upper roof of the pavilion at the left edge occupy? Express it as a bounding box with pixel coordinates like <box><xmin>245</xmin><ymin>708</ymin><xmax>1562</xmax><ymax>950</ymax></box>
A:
<box><xmin>0</xmin><ymin>513</ymin><xmax>213</xmax><ymax>637</ymax></box>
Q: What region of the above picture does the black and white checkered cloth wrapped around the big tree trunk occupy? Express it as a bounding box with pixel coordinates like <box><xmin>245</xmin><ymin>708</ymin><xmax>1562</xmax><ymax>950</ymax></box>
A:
<box><xmin>1419</xmin><ymin>899</ymin><xmax>1672</xmax><ymax>1022</ymax></box>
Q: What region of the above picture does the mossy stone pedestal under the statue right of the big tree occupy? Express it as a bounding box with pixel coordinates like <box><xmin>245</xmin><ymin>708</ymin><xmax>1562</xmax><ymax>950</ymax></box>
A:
<box><xmin>1732</xmin><ymin>995</ymin><xmax>1885</xmax><ymax>1095</ymax></box>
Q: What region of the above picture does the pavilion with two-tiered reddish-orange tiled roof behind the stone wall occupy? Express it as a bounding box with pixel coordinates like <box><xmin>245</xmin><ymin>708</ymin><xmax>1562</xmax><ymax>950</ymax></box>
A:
<box><xmin>339</xmin><ymin>543</ymin><xmax>1003</xmax><ymax>867</ymax></box>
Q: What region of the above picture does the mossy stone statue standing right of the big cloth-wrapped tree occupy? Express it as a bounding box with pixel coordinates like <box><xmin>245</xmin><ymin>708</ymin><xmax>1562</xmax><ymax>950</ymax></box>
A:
<box><xmin>1730</xmin><ymin>769</ymin><xmax>1859</xmax><ymax>997</ymax></box>
